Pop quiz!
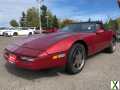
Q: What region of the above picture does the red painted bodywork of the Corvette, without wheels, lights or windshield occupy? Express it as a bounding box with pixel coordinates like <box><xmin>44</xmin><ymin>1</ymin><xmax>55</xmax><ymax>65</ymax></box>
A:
<box><xmin>4</xmin><ymin>22</ymin><xmax>115</xmax><ymax>70</ymax></box>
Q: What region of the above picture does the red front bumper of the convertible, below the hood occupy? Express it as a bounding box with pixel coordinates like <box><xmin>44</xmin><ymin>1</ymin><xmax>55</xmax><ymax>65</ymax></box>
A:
<box><xmin>4</xmin><ymin>52</ymin><xmax>66</xmax><ymax>70</ymax></box>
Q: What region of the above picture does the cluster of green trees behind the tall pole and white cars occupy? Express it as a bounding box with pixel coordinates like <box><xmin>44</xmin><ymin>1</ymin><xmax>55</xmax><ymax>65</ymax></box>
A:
<box><xmin>10</xmin><ymin>5</ymin><xmax>74</xmax><ymax>30</ymax></box>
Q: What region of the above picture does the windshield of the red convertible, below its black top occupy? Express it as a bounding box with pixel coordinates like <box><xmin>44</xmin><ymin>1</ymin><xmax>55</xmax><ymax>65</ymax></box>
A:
<box><xmin>61</xmin><ymin>23</ymin><xmax>97</xmax><ymax>33</ymax></box>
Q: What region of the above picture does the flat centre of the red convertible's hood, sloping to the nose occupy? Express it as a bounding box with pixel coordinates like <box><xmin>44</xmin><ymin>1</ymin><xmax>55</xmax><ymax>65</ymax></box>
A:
<box><xmin>14</xmin><ymin>32</ymin><xmax>73</xmax><ymax>50</ymax></box>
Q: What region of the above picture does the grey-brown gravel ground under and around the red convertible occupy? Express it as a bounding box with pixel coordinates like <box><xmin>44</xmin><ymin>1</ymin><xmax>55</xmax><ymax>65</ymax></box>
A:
<box><xmin>0</xmin><ymin>37</ymin><xmax>120</xmax><ymax>90</ymax></box>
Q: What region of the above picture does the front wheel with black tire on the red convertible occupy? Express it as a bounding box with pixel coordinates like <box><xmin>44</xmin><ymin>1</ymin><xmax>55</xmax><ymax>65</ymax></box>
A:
<box><xmin>66</xmin><ymin>43</ymin><xmax>86</xmax><ymax>74</ymax></box>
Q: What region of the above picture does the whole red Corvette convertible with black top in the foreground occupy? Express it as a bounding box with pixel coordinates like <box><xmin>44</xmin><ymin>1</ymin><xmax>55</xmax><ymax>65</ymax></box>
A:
<box><xmin>4</xmin><ymin>22</ymin><xmax>116</xmax><ymax>74</ymax></box>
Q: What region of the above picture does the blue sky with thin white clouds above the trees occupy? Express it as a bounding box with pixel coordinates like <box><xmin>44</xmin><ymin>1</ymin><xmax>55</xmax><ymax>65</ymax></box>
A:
<box><xmin>0</xmin><ymin>0</ymin><xmax>120</xmax><ymax>26</ymax></box>
